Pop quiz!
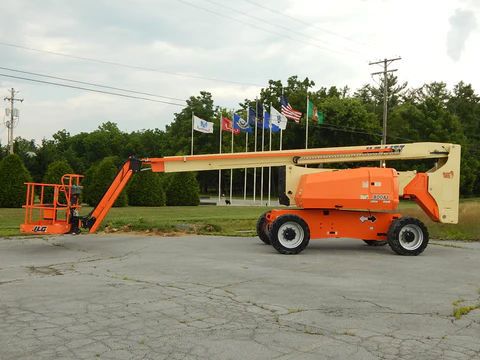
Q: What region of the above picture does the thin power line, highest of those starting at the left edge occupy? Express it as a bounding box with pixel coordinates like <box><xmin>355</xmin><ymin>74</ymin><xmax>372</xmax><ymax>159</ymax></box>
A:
<box><xmin>0</xmin><ymin>41</ymin><xmax>262</xmax><ymax>87</ymax></box>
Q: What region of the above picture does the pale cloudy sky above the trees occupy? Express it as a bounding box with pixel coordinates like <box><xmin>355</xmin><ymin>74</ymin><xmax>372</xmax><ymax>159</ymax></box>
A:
<box><xmin>0</xmin><ymin>0</ymin><xmax>480</xmax><ymax>145</ymax></box>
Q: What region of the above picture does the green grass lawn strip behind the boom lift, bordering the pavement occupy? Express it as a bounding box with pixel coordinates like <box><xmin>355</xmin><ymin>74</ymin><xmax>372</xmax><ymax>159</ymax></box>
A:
<box><xmin>0</xmin><ymin>199</ymin><xmax>480</xmax><ymax>241</ymax></box>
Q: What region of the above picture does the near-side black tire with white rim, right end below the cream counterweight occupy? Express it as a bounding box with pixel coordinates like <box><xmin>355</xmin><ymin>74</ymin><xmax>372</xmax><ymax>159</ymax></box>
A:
<box><xmin>387</xmin><ymin>217</ymin><xmax>429</xmax><ymax>256</ymax></box>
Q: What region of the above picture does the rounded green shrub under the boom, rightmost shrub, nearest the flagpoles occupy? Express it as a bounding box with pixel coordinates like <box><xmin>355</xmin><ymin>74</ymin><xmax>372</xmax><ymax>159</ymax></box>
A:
<box><xmin>166</xmin><ymin>172</ymin><xmax>200</xmax><ymax>206</ymax></box>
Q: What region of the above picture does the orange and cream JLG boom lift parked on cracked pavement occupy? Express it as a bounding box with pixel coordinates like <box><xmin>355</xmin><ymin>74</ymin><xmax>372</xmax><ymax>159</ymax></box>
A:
<box><xmin>21</xmin><ymin>142</ymin><xmax>460</xmax><ymax>255</ymax></box>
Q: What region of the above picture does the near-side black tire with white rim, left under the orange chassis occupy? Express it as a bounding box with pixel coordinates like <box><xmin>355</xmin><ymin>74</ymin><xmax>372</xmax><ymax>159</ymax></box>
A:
<box><xmin>270</xmin><ymin>215</ymin><xmax>310</xmax><ymax>255</ymax></box>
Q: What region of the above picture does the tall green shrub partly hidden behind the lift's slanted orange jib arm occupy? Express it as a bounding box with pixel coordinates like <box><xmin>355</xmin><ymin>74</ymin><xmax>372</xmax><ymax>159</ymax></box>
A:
<box><xmin>83</xmin><ymin>157</ymin><xmax>128</xmax><ymax>207</ymax></box>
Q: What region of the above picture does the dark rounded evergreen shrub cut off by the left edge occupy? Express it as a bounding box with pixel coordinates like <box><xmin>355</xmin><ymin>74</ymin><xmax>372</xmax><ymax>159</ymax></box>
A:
<box><xmin>0</xmin><ymin>154</ymin><xmax>32</xmax><ymax>208</ymax></box>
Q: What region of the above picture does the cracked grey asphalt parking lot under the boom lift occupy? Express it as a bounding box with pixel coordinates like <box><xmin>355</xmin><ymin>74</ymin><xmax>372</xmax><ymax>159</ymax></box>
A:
<box><xmin>0</xmin><ymin>234</ymin><xmax>480</xmax><ymax>360</ymax></box>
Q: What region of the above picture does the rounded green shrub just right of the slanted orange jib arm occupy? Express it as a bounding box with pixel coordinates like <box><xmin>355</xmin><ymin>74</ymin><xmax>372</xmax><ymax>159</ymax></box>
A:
<box><xmin>127</xmin><ymin>171</ymin><xmax>165</xmax><ymax>206</ymax></box>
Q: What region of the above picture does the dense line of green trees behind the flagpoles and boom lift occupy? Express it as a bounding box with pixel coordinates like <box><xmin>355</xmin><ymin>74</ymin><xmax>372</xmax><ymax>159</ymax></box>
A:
<box><xmin>0</xmin><ymin>75</ymin><xmax>480</xmax><ymax>206</ymax></box>
